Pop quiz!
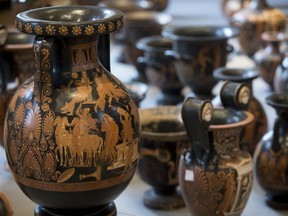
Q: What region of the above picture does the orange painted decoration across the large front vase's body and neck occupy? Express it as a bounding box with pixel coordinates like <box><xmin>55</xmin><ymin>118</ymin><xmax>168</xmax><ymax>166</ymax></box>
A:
<box><xmin>5</xmin><ymin>38</ymin><xmax>140</xmax><ymax>192</ymax></box>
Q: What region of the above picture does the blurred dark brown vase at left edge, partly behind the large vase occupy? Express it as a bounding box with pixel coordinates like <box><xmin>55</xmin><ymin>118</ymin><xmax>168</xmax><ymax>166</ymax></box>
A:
<box><xmin>0</xmin><ymin>32</ymin><xmax>34</xmax><ymax>145</ymax></box>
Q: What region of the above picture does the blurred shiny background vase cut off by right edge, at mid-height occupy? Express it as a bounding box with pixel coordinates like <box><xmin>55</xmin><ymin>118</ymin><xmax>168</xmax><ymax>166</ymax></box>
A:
<box><xmin>273</xmin><ymin>53</ymin><xmax>288</xmax><ymax>93</ymax></box>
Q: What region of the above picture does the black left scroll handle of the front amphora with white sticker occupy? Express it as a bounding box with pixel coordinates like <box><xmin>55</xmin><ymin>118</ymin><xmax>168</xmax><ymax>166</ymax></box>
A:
<box><xmin>181</xmin><ymin>97</ymin><xmax>213</xmax><ymax>166</ymax></box>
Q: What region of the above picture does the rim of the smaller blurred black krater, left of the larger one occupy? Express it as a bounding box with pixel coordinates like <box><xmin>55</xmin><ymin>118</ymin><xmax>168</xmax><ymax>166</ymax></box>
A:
<box><xmin>136</xmin><ymin>35</ymin><xmax>172</xmax><ymax>53</ymax></box>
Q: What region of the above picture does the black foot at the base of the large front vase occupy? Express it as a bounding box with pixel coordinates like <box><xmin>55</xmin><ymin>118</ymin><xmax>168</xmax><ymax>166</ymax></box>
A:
<box><xmin>34</xmin><ymin>202</ymin><xmax>117</xmax><ymax>216</ymax></box>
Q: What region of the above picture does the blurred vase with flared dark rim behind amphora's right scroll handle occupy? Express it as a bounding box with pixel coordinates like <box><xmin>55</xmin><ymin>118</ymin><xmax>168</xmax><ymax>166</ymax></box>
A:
<box><xmin>213</xmin><ymin>67</ymin><xmax>268</xmax><ymax>156</ymax></box>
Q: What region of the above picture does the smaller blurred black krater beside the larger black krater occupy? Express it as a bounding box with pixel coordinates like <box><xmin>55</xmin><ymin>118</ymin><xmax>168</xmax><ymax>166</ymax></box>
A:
<box><xmin>136</xmin><ymin>35</ymin><xmax>184</xmax><ymax>105</ymax></box>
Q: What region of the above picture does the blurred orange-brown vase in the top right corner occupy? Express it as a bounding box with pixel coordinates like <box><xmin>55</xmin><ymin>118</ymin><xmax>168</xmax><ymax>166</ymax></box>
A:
<box><xmin>230</xmin><ymin>0</ymin><xmax>286</xmax><ymax>56</ymax></box>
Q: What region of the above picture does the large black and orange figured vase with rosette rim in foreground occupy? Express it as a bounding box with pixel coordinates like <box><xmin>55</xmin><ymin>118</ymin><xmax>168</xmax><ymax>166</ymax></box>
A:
<box><xmin>4</xmin><ymin>6</ymin><xmax>141</xmax><ymax>215</ymax></box>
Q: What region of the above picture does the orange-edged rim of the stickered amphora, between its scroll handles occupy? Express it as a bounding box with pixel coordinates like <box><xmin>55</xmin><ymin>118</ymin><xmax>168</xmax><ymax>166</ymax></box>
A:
<box><xmin>209</xmin><ymin>109</ymin><xmax>254</xmax><ymax>131</ymax></box>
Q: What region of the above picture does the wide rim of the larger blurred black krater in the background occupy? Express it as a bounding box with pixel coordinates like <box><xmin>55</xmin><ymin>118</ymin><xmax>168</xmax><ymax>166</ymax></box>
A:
<box><xmin>162</xmin><ymin>26</ymin><xmax>239</xmax><ymax>42</ymax></box>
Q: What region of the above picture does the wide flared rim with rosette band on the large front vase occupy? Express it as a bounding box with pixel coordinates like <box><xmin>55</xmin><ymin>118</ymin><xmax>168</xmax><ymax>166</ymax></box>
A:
<box><xmin>15</xmin><ymin>5</ymin><xmax>124</xmax><ymax>37</ymax></box>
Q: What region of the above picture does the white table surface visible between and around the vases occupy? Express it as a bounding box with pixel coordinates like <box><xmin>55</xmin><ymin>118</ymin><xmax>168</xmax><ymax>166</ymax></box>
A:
<box><xmin>0</xmin><ymin>0</ymin><xmax>288</xmax><ymax>216</ymax></box>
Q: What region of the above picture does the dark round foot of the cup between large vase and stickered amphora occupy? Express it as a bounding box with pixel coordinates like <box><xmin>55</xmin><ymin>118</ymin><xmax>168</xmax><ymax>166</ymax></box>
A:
<box><xmin>144</xmin><ymin>189</ymin><xmax>185</xmax><ymax>210</ymax></box>
